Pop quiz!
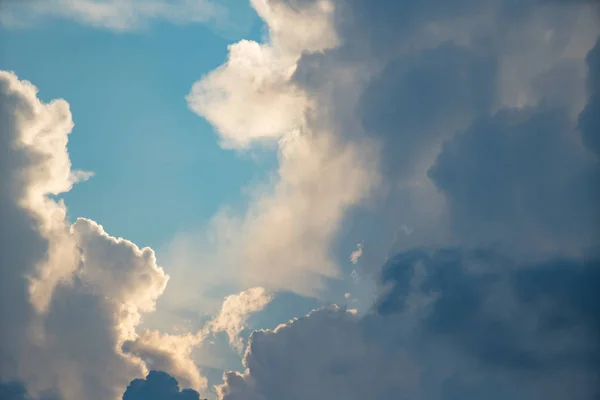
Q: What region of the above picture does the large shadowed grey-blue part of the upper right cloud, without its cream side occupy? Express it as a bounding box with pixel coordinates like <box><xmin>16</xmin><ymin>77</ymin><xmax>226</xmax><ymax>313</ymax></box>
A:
<box><xmin>284</xmin><ymin>0</ymin><xmax>599</xmax><ymax>268</ymax></box>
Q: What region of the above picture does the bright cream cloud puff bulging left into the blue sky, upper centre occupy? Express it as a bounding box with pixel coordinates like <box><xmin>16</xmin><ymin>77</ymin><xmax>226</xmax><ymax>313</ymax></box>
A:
<box><xmin>187</xmin><ymin>40</ymin><xmax>309</xmax><ymax>148</ymax></box>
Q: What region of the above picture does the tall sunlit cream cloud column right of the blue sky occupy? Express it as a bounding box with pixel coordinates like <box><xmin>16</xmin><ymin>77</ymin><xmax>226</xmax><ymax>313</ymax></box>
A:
<box><xmin>187</xmin><ymin>0</ymin><xmax>378</xmax><ymax>294</ymax></box>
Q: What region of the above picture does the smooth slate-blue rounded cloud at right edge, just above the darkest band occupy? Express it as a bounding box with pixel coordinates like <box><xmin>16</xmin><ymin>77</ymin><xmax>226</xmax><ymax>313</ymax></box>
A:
<box><xmin>428</xmin><ymin>103</ymin><xmax>600</xmax><ymax>253</ymax></box>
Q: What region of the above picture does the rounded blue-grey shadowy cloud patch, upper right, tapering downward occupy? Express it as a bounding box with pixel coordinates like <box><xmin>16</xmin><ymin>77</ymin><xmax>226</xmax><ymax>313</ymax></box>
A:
<box><xmin>359</xmin><ymin>43</ymin><xmax>497</xmax><ymax>177</ymax></box>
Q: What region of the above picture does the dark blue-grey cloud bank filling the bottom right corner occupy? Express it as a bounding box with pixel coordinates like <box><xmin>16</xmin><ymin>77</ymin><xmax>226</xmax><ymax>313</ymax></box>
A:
<box><xmin>220</xmin><ymin>249</ymin><xmax>600</xmax><ymax>400</ymax></box>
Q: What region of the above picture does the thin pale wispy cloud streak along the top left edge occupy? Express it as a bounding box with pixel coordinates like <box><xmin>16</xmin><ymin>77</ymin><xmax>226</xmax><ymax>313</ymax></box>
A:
<box><xmin>0</xmin><ymin>0</ymin><xmax>227</xmax><ymax>31</ymax></box>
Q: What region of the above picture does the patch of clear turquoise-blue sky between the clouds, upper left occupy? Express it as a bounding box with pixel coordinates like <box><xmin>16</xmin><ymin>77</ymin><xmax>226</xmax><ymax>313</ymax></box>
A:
<box><xmin>0</xmin><ymin>3</ymin><xmax>276</xmax><ymax>248</ymax></box>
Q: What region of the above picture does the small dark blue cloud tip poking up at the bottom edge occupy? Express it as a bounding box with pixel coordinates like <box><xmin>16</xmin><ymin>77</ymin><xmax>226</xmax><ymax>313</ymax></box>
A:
<box><xmin>123</xmin><ymin>371</ymin><xmax>206</xmax><ymax>400</ymax></box>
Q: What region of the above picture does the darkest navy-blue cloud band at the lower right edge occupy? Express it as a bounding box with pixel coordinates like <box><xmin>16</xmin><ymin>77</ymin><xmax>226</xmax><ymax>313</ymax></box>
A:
<box><xmin>376</xmin><ymin>249</ymin><xmax>600</xmax><ymax>374</ymax></box>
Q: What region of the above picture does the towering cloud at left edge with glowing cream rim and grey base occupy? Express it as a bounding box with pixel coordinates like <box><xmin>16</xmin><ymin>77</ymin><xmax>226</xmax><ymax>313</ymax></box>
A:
<box><xmin>0</xmin><ymin>71</ymin><xmax>179</xmax><ymax>400</ymax></box>
